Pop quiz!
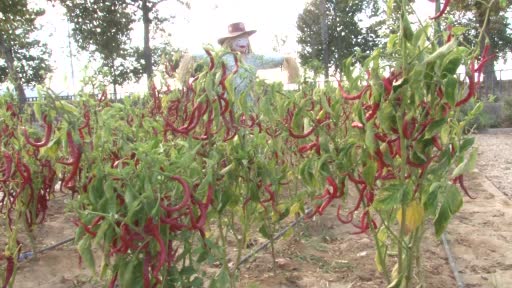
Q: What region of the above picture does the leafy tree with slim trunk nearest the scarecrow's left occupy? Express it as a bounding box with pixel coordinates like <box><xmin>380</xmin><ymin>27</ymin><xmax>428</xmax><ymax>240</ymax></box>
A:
<box><xmin>59</xmin><ymin>0</ymin><xmax>188</xmax><ymax>92</ymax></box>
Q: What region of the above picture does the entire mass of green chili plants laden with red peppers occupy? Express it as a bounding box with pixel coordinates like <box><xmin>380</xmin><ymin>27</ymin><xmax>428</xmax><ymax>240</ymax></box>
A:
<box><xmin>0</xmin><ymin>1</ymin><xmax>492</xmax><ymax>287</ymax></box>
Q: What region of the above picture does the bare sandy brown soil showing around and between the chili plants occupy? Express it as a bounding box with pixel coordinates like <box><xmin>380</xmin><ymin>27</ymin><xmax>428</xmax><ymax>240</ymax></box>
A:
<box><xmin>10</xmin><ymin>129</ymin><xmax>512</xmax><ymax>288</ymax></box>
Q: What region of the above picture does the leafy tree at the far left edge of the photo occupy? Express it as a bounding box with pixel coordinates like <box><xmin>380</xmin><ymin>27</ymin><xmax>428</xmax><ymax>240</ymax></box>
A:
<box><xmin>0</xmin><ymin>0</ymin><xmax>52</xmax><ymax>104</ymax></box>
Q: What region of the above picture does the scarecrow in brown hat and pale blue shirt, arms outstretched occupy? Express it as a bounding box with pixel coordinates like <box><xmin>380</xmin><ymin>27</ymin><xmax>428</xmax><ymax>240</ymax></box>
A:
<box><xmin>177</xmin><ymin>22</ymin><xmax>299</xmax><ymax>101</ymax></box>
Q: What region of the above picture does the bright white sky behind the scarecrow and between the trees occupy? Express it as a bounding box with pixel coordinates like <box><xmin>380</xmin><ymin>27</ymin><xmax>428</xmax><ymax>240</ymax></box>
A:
<box><xmin>32</xmin><ymin>0</ymin><xmax>512</xmax><ymax>94</ymax></box>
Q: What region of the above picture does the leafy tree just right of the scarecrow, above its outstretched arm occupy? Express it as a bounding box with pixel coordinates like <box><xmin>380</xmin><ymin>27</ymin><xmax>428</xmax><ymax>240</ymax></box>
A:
<box><xmin>297</xmin><ymin>0</ymin><xmax>379</xmax><ymax>76</ymax></box>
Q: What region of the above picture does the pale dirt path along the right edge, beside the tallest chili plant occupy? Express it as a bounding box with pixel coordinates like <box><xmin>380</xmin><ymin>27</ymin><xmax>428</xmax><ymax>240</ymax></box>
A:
<box><xmin>447</xmin><ymin>133</ymin><xmax>512</xmax><ymax>287</ymax></box>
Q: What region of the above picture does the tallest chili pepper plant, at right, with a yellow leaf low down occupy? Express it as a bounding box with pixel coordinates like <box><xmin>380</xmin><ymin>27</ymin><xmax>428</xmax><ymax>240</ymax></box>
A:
<box><xmin>292</xmin><ymin>1</ymin><xmax>492</xmax><ymax>287</ymax></box>
